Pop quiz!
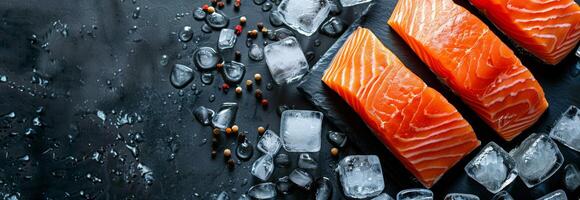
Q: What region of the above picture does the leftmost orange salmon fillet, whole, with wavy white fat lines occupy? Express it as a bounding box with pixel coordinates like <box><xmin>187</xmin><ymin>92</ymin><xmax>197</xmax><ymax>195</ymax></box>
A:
<box><xmin>322</xmin><ymin>27</ymin><xmax>480</xmax><ymax>187</ymax></box>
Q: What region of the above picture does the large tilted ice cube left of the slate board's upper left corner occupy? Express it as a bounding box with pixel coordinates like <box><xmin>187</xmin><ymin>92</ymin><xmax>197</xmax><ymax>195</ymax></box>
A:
<box><xmin>264</xmin><ymin>37</ymin><xmax>308</xmax><ymax>84</ymax></box>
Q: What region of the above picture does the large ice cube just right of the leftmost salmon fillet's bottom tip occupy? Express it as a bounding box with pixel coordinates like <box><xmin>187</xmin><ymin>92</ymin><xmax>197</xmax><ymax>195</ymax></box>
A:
<box><xmin>465</xmin><ymin>142</ymin><xmax>517</xmax><ymax>193</ymax></box>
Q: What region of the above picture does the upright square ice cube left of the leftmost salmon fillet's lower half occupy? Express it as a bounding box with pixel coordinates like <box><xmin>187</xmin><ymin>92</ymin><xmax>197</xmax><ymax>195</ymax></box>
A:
<box><xmin>280</xmin><ymin>110</ymin><xmax>323</xmax><ymax>152</ymax></box>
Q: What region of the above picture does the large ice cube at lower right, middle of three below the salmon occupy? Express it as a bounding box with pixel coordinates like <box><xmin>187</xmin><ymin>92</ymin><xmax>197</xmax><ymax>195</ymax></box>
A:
<box><xmin>510</xmin><ymin>133</ymin><xmax>564</xmax><ymax>188</ymax></box>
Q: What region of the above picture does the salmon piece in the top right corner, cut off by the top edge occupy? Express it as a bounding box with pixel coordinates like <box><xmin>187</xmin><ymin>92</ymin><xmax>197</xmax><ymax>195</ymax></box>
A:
<box><xmin>469</xmin><ymin>0</ymin><xmax>580</xmax><ymax>65</ymax></box>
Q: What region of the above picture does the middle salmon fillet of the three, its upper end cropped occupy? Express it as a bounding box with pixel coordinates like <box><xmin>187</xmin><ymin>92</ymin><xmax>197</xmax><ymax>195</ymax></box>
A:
<box><xmin>388</xmin><ymin>0</ymin><xmax>548</xmax><ymax>141</ymax></box>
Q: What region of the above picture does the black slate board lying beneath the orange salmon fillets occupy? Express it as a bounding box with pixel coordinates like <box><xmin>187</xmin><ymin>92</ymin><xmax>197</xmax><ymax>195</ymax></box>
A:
<box><xmin>298</xmin><ymin>0</ymin><xmax>580</xmax><ymax>199</ymax></box>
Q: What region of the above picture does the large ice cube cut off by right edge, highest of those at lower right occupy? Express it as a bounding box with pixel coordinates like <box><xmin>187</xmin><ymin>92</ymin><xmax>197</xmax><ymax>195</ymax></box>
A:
<box><xmin>550</xmin><ymin>106</ymin><xmax>580</xmax><ymax>152</ymax></box>
